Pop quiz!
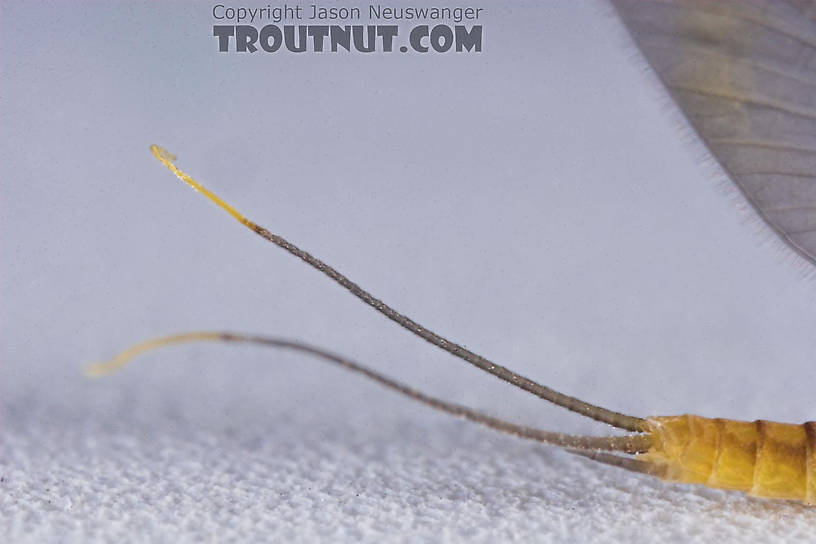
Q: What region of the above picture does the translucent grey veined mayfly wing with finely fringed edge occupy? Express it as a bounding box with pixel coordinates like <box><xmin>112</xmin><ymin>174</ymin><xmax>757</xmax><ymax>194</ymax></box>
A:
<box><xmin>612</xmin><ymin>0</ymin><xmax>816</xmax><ymax>264</ymax></box>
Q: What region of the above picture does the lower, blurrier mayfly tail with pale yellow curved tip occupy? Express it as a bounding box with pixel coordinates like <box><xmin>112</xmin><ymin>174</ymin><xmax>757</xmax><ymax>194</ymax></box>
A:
<box><xmin>86</xmin><ymin>331</ymin><xmax>651</xmax><ymax>453</ymax></box>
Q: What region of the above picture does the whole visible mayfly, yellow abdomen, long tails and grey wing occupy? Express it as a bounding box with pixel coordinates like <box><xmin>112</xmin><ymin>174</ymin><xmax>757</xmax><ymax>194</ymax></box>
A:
<box><xmin>89</xmin><ymin>0</ymin><xmax>816</xmax><ymax>504</ymax></box>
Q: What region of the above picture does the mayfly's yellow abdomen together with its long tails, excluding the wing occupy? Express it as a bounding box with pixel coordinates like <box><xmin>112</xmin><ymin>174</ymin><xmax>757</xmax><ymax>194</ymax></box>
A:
<box><xmin>88</xmin><ymin>145</ymin><xmax>816</xmax><ymax>504</ymax></box>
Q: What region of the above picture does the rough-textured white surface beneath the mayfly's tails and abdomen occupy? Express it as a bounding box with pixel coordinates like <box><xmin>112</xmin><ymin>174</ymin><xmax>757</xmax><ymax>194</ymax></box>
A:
<box><xmin>6</xmin><ymin>382</ymin><xmax>816</xmax><ymax>542</ymax></box>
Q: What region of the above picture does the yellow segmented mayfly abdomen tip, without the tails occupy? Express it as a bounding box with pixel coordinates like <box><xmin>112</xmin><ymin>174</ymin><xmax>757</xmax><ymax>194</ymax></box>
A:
<box><xmin>640</xmin><ymin>415</ymin><xmax>816</xmax><ymax>504</ymax></box>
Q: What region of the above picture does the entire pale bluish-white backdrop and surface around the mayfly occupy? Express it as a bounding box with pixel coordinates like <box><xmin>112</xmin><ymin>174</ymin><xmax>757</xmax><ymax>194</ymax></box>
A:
<box><xmin>0</xmin><ymin>2</ymin><xmax>816</xmax><ymax>542</ymax></box>
